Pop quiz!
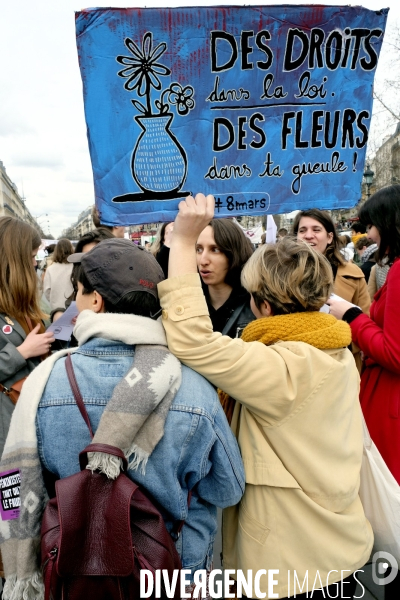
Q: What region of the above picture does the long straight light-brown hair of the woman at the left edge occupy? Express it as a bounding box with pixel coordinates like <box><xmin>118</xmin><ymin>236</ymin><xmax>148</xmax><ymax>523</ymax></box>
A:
<box><xmin>0</xmin><ymin>217</ymin><xmax>46</xmax><ymax>323</ymax></box>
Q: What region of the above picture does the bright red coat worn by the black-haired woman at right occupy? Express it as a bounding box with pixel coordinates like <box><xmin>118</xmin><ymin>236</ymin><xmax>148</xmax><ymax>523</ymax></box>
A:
<box><xmin>350</xmin><ymin>259</ymin><xmax>400</xmax><ymax>484</ymax></box>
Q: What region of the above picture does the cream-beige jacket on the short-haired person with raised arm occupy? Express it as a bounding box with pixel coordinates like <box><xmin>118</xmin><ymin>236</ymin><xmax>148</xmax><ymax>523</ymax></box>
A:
<box><xmin>158</xmin><ymin>274</ymin><xmax>373</xmax><ymax>598</ymax></box>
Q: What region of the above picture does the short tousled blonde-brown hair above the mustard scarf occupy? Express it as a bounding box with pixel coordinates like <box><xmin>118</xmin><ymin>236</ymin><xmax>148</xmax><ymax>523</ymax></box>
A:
<box><xmin>242</xmin><ymin>236</ymin><xmax>333</xmax><ymax>315</ymax></box>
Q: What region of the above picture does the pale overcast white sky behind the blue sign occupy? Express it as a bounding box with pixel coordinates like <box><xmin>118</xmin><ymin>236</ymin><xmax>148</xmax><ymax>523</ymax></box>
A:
<box><xmin>0</xmin><ymin>0</ymin><xmax>400</xmax><ymax>237</ymax></box>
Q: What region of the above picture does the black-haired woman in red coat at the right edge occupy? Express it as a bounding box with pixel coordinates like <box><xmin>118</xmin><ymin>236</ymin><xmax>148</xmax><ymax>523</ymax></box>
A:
<box><xmin>329</xmin><ymin>185</ymin><xmax>400</xmax><ymax>484</ymax></box>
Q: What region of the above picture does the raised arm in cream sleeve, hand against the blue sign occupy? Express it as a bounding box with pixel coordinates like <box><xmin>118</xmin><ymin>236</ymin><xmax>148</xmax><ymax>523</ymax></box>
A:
<box><xmin>158</xmin><ymin>195</ymin><xmax>328</xmax><ymax>424</ymax></box>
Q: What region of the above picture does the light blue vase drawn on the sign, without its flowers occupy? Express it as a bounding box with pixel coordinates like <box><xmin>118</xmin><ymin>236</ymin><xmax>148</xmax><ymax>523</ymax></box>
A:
<box><xmin>132</xmin><ymin>113</ymin><xmax>187</xmax><ymax>194</ymax></box>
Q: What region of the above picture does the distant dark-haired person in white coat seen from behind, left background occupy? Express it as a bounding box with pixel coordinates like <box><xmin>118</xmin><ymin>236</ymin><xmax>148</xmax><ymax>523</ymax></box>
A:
<box><xmin>43</xmin><ymin>238</ymin><xmax>74</xmax><ymax>311</ymax></box>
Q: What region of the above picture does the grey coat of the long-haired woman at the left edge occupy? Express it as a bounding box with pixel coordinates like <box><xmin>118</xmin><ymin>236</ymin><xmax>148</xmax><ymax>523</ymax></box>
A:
<box><xmin>0</xmin><ymin>313</ymin><xmax>40</xmax><ymax>456</ymax></box>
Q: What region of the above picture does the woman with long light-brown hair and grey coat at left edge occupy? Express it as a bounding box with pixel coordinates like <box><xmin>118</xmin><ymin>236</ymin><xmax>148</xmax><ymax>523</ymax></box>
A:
<box><xmin>0</xmin><ymin>217</ymin><xmax>54</xmax><ymax>454</ymax></box>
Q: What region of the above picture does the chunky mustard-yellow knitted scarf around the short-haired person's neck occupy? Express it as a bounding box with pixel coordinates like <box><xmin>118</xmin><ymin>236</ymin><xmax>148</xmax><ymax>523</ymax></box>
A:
<box><xmin>218</xmin><ymin>312</ymin><xmax>351</xmax><ymax>423</ymax></box>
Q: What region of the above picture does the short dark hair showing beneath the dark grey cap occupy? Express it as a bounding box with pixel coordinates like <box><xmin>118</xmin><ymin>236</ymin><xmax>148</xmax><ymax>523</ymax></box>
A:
<box><xmin>76</xmin><ymin>264</ymin><xmax>161</xmax><ymax>318</ymax></box>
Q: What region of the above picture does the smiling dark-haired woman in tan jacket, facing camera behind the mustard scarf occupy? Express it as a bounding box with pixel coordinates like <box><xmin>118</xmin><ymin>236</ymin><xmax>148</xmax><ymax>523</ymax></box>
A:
<box><xmin>292</xmin><ymin>208</ymin><xmax>371</xmax><ymax>371</ymax></box>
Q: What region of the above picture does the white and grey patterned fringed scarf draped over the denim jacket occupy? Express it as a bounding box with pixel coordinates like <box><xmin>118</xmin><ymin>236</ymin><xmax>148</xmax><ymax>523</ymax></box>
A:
<box><xmin>0</xmin><ymin>310</ymin><xmax>181</xmax><ymax>600</ymax></box>
